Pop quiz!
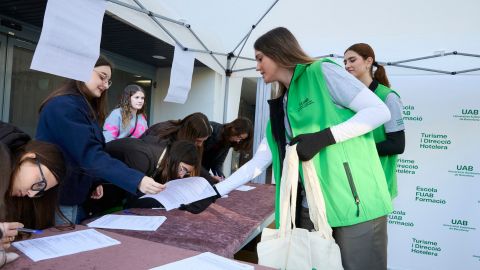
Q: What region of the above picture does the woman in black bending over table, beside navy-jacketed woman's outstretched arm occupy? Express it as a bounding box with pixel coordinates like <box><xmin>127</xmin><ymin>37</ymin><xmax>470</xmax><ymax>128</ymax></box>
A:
<box><xmin>106</xmin><ymin>136</ymin><xmax>200</xmax><ymax>208</ymax></box>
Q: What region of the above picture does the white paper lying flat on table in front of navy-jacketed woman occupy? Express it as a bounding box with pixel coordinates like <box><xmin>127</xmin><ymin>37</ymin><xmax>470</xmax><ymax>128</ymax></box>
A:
<box><xmin>87</xmin><ymin>215</ymin><xmax>167</xmax><ymax>231</ymax></box>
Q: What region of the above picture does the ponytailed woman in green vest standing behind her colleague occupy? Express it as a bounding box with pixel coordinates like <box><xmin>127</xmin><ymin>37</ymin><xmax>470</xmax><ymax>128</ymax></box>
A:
<box><xmin>343</xmin><ymin>43</ymin><xmax>405</xmax><ymax>199</ymax></box>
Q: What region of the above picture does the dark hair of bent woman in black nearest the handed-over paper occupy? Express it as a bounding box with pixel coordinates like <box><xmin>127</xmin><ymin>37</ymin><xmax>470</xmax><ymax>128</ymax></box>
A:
<box><xmin>157</xmin><ymin>140</ymin><xmax>201</xmax><ymax>184</ymax></box>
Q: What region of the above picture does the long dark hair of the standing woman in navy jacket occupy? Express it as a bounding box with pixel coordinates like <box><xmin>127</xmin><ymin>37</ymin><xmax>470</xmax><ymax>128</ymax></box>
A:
<box><xmin>39</xmin><ymin>55</ymin><xmax>113</xmax><ymax>126</ymax></box>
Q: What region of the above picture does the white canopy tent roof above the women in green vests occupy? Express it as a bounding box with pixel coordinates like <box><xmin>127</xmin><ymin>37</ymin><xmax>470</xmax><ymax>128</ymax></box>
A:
<box><xmin>107</xmin><ymin>0</ymin><xmax>480</xmax><ymax>77</ymax></box>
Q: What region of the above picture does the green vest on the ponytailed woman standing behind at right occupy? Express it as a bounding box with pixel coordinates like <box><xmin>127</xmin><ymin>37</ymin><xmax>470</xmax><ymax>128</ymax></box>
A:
<box><xmin>373</xmin><ymin>84</ymin><xmax>400</xmax><ymax>199</ymax></box>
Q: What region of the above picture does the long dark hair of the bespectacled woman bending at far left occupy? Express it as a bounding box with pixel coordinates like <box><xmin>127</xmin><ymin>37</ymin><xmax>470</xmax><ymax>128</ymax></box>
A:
<box><xmin>0</xmin><ymin>140</ymin><xmax>65</xmax><ymax>229</ymax></box>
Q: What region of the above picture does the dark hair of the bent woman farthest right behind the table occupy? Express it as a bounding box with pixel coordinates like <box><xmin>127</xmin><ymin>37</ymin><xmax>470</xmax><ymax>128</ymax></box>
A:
<box><xmin>222</xmin><ymin>117</ymin><xmax>253</xmax><ymax>152</ymax></box>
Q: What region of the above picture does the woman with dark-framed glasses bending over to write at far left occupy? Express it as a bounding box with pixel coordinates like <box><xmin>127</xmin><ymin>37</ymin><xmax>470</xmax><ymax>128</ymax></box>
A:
<box><xmin>0</xmin><ymin>122</ymin><xmax>65</xmax><ymax>251</ymax></box>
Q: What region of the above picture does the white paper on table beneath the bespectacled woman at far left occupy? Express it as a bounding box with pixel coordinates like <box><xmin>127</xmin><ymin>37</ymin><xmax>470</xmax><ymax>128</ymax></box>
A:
<box><xmin>13</xmin><ymin>229</ymin><xmax>120</xmax><ymax>262</ymax></box>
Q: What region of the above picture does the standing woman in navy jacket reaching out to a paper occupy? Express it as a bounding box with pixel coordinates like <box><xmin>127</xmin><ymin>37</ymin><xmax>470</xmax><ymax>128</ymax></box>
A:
<box><xmin>36</xmin><ymin>56</ymin><xmax>165</xmax><ymax>223</ymax></box>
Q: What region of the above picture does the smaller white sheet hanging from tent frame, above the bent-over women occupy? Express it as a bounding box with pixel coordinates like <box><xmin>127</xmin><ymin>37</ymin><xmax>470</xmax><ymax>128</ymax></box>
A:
<box><xmin>163</xmin><ymin>46</ymin><xmax>195</xmax><ymax>104</ymax></box>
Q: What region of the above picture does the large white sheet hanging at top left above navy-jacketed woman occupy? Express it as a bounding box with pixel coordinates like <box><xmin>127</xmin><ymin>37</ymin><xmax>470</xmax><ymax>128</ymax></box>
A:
<box><xmin>30</xmin><ymin>0</ymin><xmax>106</xmax><ymax>82</ymax></box>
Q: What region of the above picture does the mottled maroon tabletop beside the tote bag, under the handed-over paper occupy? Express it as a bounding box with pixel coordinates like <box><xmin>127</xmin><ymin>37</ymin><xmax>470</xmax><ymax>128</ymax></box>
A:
<box><xmin>84</xmin><ymin>184</ymin><xmax>275</xmax><ymax>258</ymax></box>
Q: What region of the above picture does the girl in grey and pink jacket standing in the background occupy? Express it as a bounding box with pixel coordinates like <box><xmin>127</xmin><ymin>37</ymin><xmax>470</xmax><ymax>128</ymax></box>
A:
<box><xmin>103</xmin><ymin>84</ymin><xmax>148</xmax><ymax>142</ymax></box>
